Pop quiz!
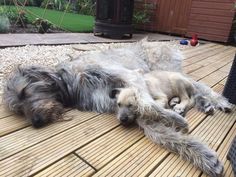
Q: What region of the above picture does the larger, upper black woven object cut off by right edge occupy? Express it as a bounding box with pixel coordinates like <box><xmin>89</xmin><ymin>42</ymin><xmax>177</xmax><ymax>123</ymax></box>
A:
<box><xmin>223</xmin><ymin>54</ymin><xmax>236</xmax><ymax>104</ymax></box>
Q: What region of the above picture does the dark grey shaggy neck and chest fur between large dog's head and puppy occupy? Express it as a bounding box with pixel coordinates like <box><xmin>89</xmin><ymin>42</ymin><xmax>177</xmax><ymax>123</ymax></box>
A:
<box><xmin>58</xmin><ymin>67</ymin><xmax>126</xmax><ymax>113</ymax></box>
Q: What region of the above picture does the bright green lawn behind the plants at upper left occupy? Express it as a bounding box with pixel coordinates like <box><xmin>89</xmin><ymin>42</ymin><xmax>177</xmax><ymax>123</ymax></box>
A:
<box><xmin>1</xmin><ymin>6</ymin><xmax>94</xmax><ymax>32</ymax></box>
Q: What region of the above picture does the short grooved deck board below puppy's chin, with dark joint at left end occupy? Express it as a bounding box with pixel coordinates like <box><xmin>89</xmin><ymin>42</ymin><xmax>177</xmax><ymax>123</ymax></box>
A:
<box><xmin>76</xmin><ymin>127</ymin><xmax>144</xmax><ymax>169</ymax></box>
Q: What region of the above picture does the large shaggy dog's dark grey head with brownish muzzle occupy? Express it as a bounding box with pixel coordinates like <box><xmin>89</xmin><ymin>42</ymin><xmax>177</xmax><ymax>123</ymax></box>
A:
<box><xmin>3</xmin><ymin>67</ymin><xmax>67</xmax><ymax>127</ymax></box>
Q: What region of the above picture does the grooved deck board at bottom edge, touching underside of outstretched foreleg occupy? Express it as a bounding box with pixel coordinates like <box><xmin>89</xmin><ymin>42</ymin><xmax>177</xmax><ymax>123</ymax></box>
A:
<box><xmin>91</xmin><ymin>137</ymin><xmax>169</xmax><ymax>176</ymax></box>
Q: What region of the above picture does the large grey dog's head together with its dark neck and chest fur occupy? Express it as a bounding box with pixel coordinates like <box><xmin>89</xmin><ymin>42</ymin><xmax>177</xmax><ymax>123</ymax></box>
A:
<box><xmin>3</xmin><ymin>66</ymin><xmax>124</xmax><ymax>127</ymax></box>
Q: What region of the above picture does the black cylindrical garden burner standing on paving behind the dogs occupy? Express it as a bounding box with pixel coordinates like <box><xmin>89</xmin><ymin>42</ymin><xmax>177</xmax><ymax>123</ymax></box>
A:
<box><xmin>94</xmin><ymin>0</ymin><xmax>134</xmax><ymax>38</ymax></box>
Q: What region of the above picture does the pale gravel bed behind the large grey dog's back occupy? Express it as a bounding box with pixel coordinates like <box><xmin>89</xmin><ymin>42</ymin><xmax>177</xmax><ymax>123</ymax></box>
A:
<box><xmin>0</xmin><ymin>41</ymin><xmax>192</xmax><ymax>95</ymax></box>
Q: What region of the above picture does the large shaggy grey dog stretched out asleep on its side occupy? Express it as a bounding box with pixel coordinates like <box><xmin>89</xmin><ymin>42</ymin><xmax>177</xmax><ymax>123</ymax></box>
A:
<box><xmin>4</xmin><ymin>41</ymin><xmax>230</xmax><ymax>176</ymax></box>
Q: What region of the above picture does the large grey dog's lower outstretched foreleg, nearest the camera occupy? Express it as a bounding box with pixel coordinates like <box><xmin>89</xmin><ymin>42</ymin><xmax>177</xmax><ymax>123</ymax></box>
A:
<box><xmin>137</xmin><ymin>119</ymin><xmax>223</xmax><ymax>177</ymax></box>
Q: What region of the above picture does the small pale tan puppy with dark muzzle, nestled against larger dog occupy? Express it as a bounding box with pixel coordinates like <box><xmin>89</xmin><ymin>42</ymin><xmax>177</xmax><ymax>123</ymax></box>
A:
<box><xmin>111</xmin><ymin>70</ymin><xmax>217</xmax><ymax>124</ymax></box>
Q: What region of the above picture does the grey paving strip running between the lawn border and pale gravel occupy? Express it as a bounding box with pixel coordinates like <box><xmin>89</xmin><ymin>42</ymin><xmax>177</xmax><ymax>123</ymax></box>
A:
<box><xmin>0</xmin><ymin>33</ymin><xmax>184</xmax><ymax>47</ymax></box>
